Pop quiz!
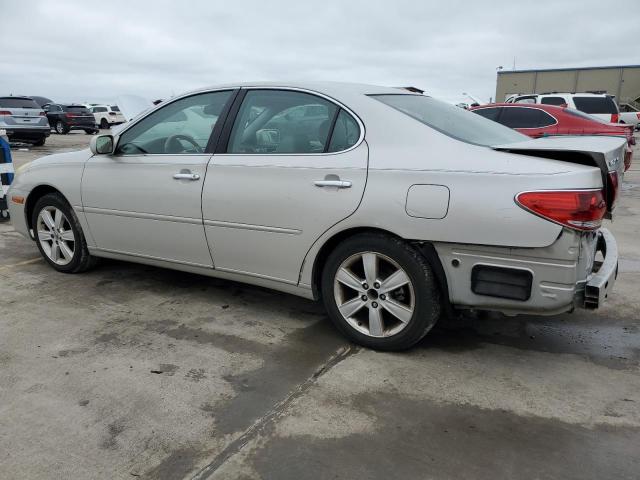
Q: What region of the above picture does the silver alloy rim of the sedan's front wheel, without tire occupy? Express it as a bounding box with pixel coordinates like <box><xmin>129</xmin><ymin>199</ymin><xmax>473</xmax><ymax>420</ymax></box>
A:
<box><xmin>36</xmin><ymin>207</ymin><xmax>76</xmax><ymax>266</ymax></box>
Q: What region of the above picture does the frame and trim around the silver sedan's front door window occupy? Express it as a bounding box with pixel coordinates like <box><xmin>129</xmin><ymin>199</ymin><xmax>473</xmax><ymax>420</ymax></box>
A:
<box><xmin>112</xmin><ymin>87</ymin><xmax>239</xmax><ymax>158</ymax></box>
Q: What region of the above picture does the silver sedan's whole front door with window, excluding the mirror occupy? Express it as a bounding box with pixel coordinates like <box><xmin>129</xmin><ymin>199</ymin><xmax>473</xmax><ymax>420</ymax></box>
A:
<box><xmin>82</xmin><ymin>90</ymin><xmax>232</xmax><ymax>267</ymax></box>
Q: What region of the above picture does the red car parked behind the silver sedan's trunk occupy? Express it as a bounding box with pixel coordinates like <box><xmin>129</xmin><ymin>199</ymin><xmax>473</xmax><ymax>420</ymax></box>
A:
<box><xmin>469</xmin><ymin>103</ymin><xmax>636</xmax><ymax>171</ymax></box>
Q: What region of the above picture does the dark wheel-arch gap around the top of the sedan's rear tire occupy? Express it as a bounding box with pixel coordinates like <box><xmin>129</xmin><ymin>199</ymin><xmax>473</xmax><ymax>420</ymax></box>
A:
<box><xmin>311</xmin><ymin>227</ymin><xmax>453</xmax><ymax>317</ymax></box>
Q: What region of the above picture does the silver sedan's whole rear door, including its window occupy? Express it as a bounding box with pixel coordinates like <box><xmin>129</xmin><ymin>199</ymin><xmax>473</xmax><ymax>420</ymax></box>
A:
<box><xmin>202</xmin><ymin>89</ymin><xmax>368</xmax><ymax>284</ymax></box>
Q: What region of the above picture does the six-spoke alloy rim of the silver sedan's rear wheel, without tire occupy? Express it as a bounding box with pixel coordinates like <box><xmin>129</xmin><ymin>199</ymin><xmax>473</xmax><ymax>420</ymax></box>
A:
<box><xmin>333</xmin><ymin>251</ymin><xmax>415</xmax><ymax>338</ymax></box>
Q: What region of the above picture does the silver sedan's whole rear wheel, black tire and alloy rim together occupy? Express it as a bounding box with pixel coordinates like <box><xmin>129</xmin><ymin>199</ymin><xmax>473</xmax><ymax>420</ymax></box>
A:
<box><xmin>321</xmin><ymin>233</ymin><xmax>441</xmax><ymax>351</ymax></box>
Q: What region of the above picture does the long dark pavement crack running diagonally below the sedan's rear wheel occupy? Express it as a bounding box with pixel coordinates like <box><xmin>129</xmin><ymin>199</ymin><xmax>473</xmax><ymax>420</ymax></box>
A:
<box><xmin>192</xmin><ymin>345</ymin><xmax>361</xmax><ymax>480</ymax></box>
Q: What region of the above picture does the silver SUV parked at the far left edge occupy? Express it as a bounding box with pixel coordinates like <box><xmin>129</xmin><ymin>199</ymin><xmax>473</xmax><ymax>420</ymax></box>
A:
<box><xmin>0</xmin><ymin>96</ymin><xmax>51</xmax><ymax>146</ymax></box>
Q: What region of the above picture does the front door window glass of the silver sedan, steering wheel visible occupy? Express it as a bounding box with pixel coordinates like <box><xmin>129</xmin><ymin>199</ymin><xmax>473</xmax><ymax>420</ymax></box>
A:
<box><xmin>116</xmin><ymin>90</ymin><xmax>231</xmax><ymax>155</ymax></box>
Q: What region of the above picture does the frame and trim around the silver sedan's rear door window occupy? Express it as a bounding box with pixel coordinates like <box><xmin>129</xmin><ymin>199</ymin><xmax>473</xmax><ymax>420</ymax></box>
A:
<box><xmin>214</xmin><ymin>86</ymin><xmax>365</xmax><ymax>157</ymax></box>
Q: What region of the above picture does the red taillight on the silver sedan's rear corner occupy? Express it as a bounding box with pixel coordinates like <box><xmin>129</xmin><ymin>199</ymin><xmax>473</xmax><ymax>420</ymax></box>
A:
<box><xmin>516</xmin><ymin>190</ymin><xmax>607</xmax><ymax>230</ymax></box>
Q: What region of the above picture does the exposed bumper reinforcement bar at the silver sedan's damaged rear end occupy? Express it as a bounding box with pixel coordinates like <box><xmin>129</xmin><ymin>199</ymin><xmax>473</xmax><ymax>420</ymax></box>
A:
<box><xmin>581</xmin><ymin>228</ymin><xmax>618</xmax><ymax>309</ymax></box>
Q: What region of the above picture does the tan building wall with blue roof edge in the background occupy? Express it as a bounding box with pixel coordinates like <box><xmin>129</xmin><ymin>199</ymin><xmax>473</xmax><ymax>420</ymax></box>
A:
<box><xmin>496</xmin><ymin>66</ymin><xmax>640</xmax><ymax>103</ymax></box>
